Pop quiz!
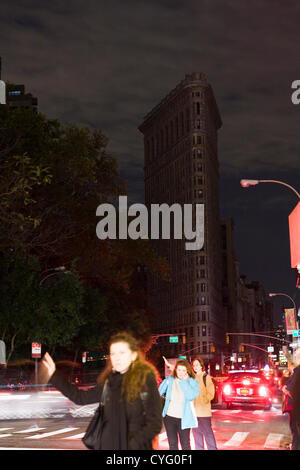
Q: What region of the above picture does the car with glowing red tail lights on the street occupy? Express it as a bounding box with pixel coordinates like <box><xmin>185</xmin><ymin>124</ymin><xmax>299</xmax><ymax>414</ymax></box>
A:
<box><xmin>222</xmin><ymin>369</ymin><xmax>273</xmax><ymax>410</ymax></box>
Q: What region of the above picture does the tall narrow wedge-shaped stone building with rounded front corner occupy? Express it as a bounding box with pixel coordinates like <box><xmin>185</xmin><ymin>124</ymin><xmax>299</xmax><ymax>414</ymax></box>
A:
<box><xmin>139</xmin><ymin>73</ymin><xmax>225</xmax><ymax>362</ymax></box>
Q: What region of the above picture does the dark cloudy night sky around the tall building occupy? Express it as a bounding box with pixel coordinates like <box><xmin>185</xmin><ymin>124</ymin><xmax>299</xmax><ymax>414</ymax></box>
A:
<box><xmin>0</xmin><ymin>0</ymin><xmax>300</xmax><ymax>324</ymax></box>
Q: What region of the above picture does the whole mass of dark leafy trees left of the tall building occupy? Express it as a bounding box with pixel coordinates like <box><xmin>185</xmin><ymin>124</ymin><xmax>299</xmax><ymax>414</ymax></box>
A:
<box><xmin>0</xmin><ymin>106</ymin><xmax>168</xmax><ymax>356</ymax></box>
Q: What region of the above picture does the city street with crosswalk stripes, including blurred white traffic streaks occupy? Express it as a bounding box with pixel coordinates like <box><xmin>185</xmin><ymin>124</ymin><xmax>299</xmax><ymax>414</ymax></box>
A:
<box><xmin>0</xmin><ymin>391</ymin><xmax>290</xmax><ymax>450</ymax></box>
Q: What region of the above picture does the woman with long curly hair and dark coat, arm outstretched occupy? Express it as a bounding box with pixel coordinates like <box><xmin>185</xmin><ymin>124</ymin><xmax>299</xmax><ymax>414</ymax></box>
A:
<box><xmin>40</xmin><ymin>332</ymin><xmax>162</xmax><ymax>450</ymax></box>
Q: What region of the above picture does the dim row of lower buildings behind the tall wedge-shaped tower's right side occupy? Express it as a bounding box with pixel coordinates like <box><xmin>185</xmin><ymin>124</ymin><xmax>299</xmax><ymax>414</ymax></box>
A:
<box><xmin>221</xmin><ymin>218</ymin><xmax>273</xmax><ymax>365</ymax></box>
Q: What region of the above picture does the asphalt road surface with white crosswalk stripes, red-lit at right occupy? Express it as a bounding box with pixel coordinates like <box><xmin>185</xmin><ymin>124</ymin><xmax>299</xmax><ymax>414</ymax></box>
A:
<box><xmin>0</xmin><ymin>406</ymin><xmax>290</xmax><ymax>450</ymax></box>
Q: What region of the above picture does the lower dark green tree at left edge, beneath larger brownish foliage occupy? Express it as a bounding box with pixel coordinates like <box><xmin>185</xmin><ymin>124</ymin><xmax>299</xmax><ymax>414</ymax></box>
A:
<box><xmin>0</xmin><ymin>254</ymin><xmax>84</xmax><ymax>362</ymax></box>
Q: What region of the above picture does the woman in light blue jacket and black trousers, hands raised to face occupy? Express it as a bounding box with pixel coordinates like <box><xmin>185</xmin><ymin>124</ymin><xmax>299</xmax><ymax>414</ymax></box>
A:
<box><xmin>159</xmin><ymin>360</ymin><xmax>199</xmax><ymax>450</ymax></box>
